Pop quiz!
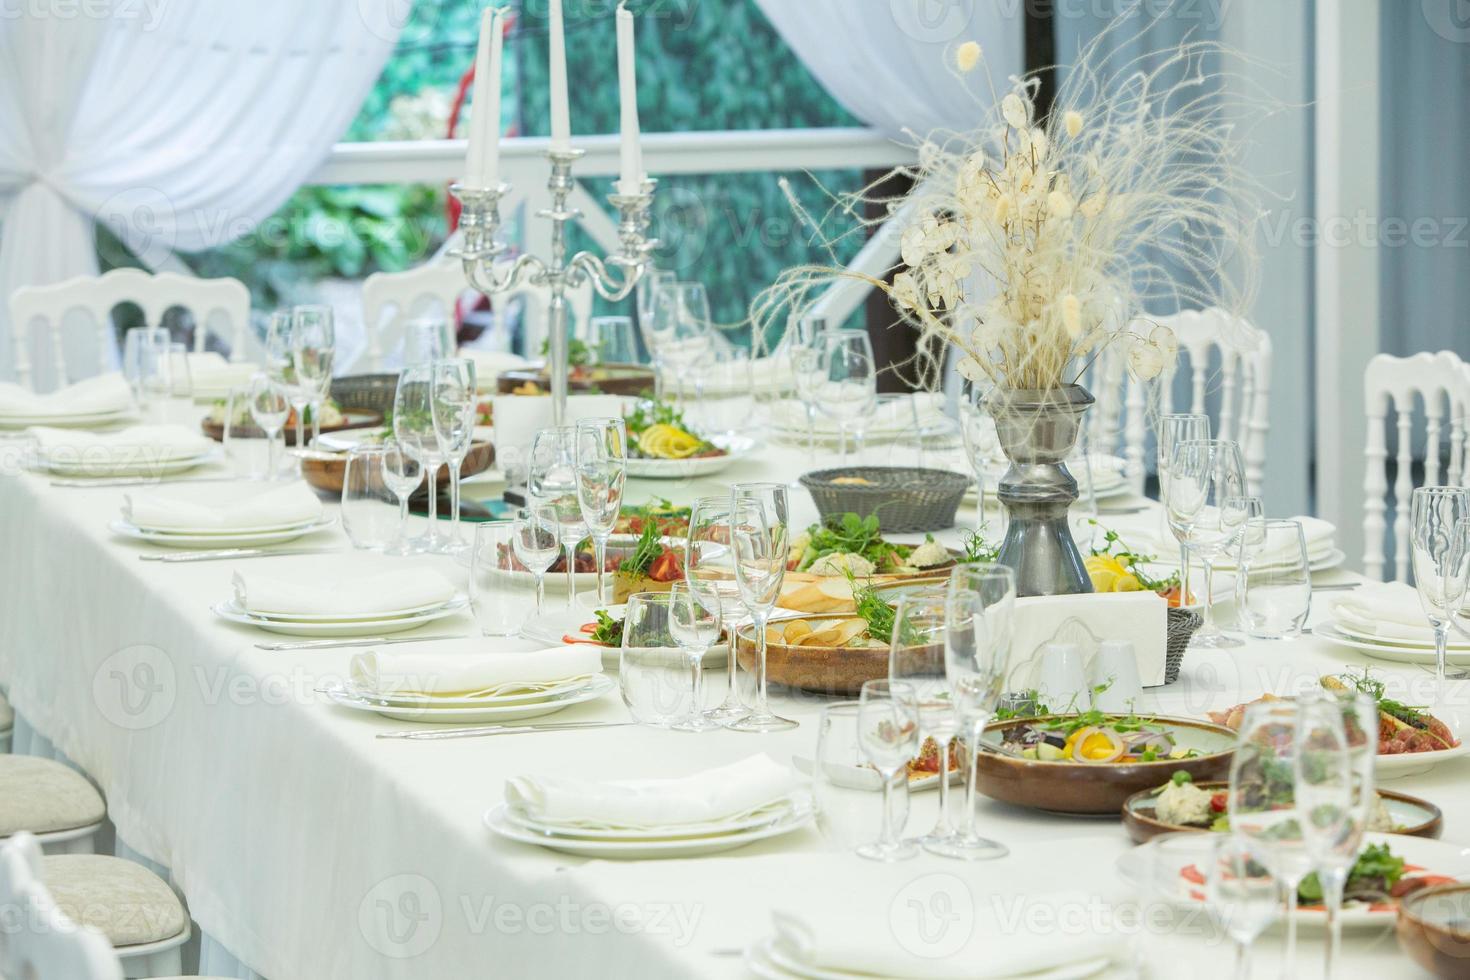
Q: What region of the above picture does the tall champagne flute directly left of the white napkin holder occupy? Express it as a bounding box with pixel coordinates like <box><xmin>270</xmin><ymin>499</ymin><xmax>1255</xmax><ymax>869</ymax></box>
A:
<box><xmin>926</xmin><ymin>561</ymin><xmax>1016</xmax><ymax>861</ymax></box>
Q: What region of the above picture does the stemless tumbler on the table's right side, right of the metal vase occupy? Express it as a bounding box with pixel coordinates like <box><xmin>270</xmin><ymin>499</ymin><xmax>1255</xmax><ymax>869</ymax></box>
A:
<box><xmin>1235</xmin><ymin>517</ymin><xmax>1311</xmax><ymax>639</ymax></box>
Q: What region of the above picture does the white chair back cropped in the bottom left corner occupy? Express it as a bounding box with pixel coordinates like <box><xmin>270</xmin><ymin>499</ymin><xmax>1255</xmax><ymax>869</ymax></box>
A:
<box><xmin>0</xmin><ymin>833</ymin><xmax>122</xmax><ymax>980</ymax></box>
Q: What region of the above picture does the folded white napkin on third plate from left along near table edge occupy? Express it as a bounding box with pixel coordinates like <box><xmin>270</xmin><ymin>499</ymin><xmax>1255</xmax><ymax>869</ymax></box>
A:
<box><xmin>122</xmin><ymin>482</ymin><xmax>322</xmax><ymax>532</ymax></box>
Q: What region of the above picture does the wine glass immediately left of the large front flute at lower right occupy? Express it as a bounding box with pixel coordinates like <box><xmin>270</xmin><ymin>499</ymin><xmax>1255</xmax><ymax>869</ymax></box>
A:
<box><xmin>1226</xmin><ymin>701</ymin><xmax>1316</xmax><ymax>977</ymax></box>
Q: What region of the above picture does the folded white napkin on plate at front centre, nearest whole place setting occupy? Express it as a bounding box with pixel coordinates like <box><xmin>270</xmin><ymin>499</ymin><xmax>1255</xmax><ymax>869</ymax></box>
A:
<box><xmin>506</xmin><ymin>754</ymin><xmax>797</xmax><ymax>827</ymax></box>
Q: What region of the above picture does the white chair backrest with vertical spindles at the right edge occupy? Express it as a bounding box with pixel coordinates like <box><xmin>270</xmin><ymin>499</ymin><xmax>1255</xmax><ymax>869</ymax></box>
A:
<box><xmin>1363</xmin><ymin>351</ymin><xmax>1470</xmax><ymax>582</ymax></box>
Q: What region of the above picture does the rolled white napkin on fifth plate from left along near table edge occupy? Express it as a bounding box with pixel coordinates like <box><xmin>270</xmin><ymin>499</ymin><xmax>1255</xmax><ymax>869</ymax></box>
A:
<box><xmin>348</xmin><ymin>638</ymin><xmax>603</xmax><ymax>698</ymax></box>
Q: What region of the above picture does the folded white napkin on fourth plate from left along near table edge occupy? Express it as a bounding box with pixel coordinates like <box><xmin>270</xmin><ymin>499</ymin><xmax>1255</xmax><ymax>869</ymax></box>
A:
<box><xmin>234</xmin><ymin>555</ymin><xmax>454</xmax><ymax>616</ymax></box>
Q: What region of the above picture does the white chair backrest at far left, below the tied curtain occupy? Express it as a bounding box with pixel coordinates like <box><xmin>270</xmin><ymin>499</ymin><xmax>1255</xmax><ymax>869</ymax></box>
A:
<box><xmin>10</xmin><ymin>269</ymin><xmax>250</xmax><ymax>388</ymax></box>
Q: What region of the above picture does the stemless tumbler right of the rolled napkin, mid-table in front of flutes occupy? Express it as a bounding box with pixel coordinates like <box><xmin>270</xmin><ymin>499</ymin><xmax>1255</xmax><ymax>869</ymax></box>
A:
<box><xmin>617</xmin><ymin>592</ymin><xmax>698</xmax><ymax>729</ymax></box>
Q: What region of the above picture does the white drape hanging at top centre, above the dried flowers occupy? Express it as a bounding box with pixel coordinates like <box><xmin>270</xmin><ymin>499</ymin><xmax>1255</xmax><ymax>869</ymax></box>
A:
<box><xmin>757</xmin><ymin>0</ymin><xmax>1025</xmax><ymax>137</ymax></box>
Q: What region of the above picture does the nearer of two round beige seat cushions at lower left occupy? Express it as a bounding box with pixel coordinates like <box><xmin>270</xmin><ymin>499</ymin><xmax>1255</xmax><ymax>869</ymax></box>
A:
<box><xmin>41</xmin><ymin>854</ymin><xmax>188</xmax><ymax>954</ymax></box>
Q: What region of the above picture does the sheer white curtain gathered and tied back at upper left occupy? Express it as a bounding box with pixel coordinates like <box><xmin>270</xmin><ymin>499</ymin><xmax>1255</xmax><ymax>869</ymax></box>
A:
<box><xmin>0</xmin><ymin>0</ymin><xmax>412</xmax><ymax>387</ymax></box>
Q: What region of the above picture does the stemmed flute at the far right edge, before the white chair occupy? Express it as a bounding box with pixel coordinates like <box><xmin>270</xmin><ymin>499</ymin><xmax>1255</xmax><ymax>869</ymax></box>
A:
<box><xmin>1410</xmin><ymin>486</ymin><xmax>1470</xmax><ymax>692</ymax></box>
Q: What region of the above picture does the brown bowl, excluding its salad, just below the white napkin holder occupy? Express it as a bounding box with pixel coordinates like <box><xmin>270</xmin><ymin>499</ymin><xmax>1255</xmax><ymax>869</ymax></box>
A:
<box><xmin>976</xmin><ymin>716</ymin><xmax>1236</xmax><ymax>817</ymax></box>
